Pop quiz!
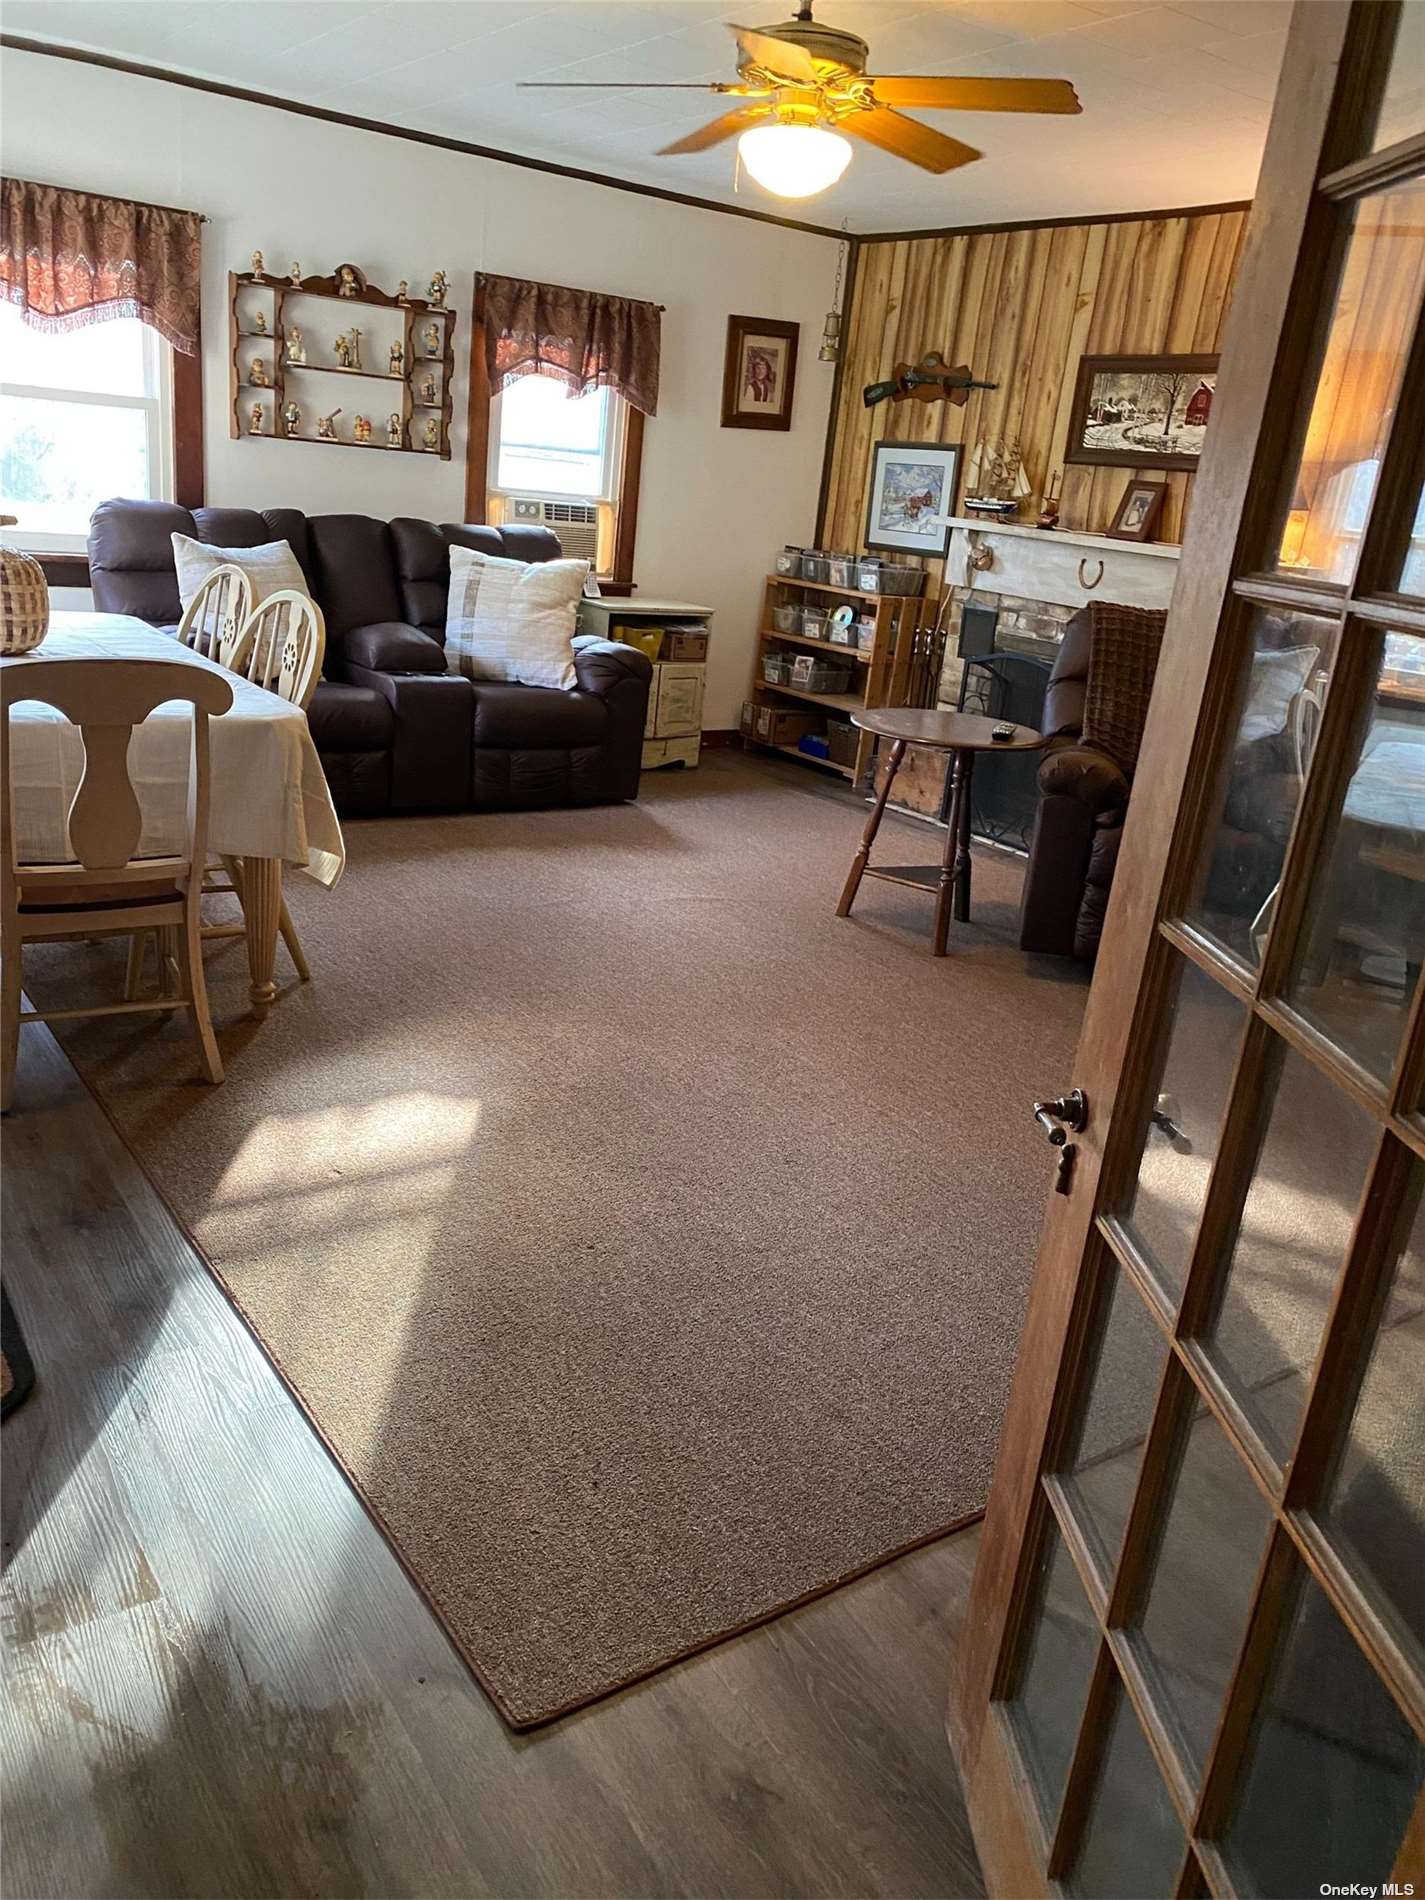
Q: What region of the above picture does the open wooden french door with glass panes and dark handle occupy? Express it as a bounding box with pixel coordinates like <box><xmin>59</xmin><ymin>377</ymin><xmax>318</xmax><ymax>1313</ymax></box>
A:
<box><xmin>950</xmin><ymin>0</ymin><xmax>1425</xmax><ymax>1900</ymax></box>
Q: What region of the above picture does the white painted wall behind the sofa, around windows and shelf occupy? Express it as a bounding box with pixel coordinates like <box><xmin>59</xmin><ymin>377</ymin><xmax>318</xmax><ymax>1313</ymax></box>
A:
<box><xmin>0</xmin><ymin>51</ymin><xmax>836</xmax><ymax>728</ymax></box>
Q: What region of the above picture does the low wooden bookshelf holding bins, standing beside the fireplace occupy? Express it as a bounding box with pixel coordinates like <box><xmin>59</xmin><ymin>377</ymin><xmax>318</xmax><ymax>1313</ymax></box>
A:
<box><xmin>752</xmin><ymin>574</ymin><xmax>925</xmax><ymax>785</ymax></box>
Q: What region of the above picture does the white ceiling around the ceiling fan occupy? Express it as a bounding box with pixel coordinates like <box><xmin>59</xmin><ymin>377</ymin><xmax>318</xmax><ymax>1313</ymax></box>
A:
<box><xmin>4</xmin><ymin>0</ymin><xmax>1290</xmax><ymax>232</ymax></box>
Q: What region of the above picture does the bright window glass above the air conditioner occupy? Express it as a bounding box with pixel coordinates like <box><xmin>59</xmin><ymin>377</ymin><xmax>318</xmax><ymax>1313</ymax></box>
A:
<box><xmin>490</xmin><ymin>376</ymin><xmax>623</xmax><ymax>504</ymax></box>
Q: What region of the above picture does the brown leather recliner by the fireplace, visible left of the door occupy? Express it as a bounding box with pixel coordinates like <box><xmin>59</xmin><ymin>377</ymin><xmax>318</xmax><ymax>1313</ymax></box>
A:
<box><xmin>1018</xmin><ymin>608</ymin><xmax>1167</xmax><ymax>961</ymax></box>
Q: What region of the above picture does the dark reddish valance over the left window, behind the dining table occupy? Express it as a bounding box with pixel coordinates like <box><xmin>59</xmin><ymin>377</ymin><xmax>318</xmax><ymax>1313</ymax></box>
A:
<box><xmin>0</xmin><ymin>179</ymin><xmax>203</xmax><ymax>355</ymax></box>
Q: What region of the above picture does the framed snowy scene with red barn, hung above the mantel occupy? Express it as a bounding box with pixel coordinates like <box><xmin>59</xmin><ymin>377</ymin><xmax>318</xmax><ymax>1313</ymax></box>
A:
<box><xmin>1064</xmin><ymin>355</ymin><xmax>1218</xmax><ymax>471</ymax></box>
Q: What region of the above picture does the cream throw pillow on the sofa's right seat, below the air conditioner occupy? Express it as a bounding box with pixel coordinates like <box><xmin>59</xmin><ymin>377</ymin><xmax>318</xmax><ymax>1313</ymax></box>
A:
<box><xmin>445</xmin><ymin>547</ymin><xmax>589</xmax><ymax>688</ymax></box>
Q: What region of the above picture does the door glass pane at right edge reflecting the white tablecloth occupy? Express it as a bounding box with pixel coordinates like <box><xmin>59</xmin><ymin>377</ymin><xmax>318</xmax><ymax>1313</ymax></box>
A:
<box><xmin>1288</xmin><ymin>631</ymin><xmax>1425</xmax><ymax>1083</ymax></box>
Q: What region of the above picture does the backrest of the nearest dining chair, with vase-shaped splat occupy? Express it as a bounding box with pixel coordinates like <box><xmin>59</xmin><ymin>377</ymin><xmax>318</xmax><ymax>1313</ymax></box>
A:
<box><xmin>0</xmin><ymin>656</ymin><xmax>232</xmax><ymax>906</ymax></box>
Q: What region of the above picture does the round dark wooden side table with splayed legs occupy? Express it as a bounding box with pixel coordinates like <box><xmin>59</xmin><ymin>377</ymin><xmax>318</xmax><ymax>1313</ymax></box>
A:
<box><xmin>836</xmin><ymin>707</ymin><xmax>1043</xmax><ymax>956</ymax></box>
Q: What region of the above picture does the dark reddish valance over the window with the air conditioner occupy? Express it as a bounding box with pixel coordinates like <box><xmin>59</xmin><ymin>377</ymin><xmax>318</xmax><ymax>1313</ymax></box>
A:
<box><xmin>475</xmin><ymin>272</ymin><xmax>663</xmax><ymax>416</ymax></box>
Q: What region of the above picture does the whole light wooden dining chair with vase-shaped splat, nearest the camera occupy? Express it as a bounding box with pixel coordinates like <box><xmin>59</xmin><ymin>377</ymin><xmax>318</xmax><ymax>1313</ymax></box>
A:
<box><xmin>0</xmin><ymin>656</ymin><xmax>232</xmax><ymax>1108</ymax></box>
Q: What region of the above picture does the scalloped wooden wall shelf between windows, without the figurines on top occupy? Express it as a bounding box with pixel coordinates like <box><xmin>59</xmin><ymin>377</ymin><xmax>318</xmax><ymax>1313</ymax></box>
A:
<box><xmin>228</xmin><ymin>264</ymin><xmax>456</xmax><ymax>462</ymax></box>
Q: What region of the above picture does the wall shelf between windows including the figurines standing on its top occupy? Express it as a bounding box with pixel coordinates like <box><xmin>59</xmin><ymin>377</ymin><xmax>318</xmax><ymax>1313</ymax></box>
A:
<box><xmin>228</xmin><ymin>251</ymin><xmax>456</xmax><ymax>462</ymax></box>
